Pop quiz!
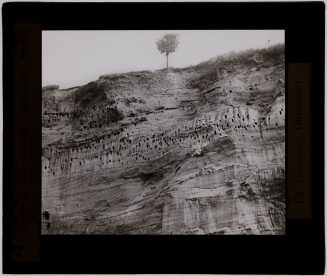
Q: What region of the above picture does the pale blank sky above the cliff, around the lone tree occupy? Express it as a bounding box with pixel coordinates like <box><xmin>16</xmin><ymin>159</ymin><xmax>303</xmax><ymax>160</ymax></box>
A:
<box><xmin>42</xmin><ymin>30</ymin><xmax>284</xmax><ymax>88</ymax></box>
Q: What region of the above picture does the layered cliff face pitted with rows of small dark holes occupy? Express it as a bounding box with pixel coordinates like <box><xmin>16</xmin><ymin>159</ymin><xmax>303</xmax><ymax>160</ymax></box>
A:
<box><xmin>42</xmin><ymin>44</ymin><xmax>285</xmax><ymax>234</ymax></box>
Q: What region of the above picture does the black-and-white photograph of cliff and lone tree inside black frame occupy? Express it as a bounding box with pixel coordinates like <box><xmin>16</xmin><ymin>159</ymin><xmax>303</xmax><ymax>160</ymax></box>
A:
<box><xmin>40</xmin><ymin>30</ymin><xmax>286</xmax><ymax>235</ymax></box>
